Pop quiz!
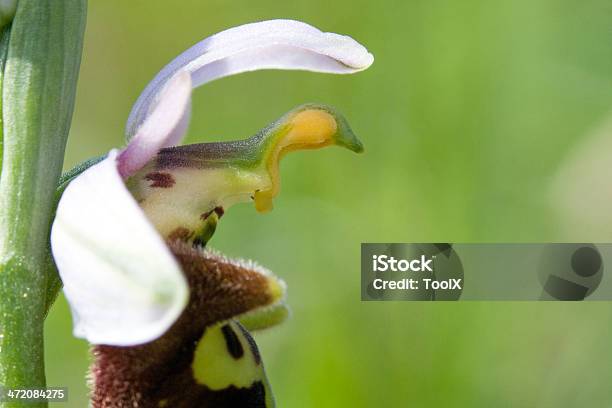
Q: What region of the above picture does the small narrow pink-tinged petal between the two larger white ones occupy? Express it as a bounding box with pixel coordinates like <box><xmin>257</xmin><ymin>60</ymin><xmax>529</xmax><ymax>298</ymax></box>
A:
<box><xmin>117</xmin><ymin>71</ymin><xmax>191</xmax><ymax>178</ymax></box>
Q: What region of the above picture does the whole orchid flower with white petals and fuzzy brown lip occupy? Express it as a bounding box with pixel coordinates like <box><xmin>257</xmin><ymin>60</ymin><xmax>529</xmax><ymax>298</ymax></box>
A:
<box><xmin>51</xmin><ymin>20</ymin><xmax>373</xmax><ymax>406</ymax></box>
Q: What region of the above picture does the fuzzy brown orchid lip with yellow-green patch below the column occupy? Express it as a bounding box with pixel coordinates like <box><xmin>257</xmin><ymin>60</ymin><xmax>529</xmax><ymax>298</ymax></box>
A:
<box><xmin>91</xmin><ymin>241</ymin><xmax>279</xmax><ymax>408</ymax></box>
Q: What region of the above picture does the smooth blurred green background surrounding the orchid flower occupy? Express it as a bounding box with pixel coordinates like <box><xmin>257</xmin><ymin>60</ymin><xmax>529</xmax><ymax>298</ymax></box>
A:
<box><xmin>46</xmin><ymin>0</ymin><xmax>612</xmax><ymax>407</ymax></box>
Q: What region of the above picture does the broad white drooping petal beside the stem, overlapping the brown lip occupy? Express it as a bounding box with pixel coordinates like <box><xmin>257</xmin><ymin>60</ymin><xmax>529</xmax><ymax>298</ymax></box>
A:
<box><xmin>51</xmin><ymin>151</ymin><xmax>188</xmax><ymax>346</ymax></box>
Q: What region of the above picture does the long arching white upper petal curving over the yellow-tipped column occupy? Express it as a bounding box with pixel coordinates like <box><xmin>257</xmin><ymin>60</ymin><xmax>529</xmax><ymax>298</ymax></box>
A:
<box><xmin>126</xmin><ymin>20</ymin><xmax>374</xmax><ymax>140</ymax></box>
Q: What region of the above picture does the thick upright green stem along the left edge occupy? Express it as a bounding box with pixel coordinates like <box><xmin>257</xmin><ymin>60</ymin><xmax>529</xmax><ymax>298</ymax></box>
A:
<box><xmin>0</xmin><ymin>0</ymin><xmax>86</xmax><ymax>407</ymax></box>
